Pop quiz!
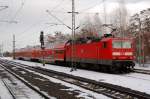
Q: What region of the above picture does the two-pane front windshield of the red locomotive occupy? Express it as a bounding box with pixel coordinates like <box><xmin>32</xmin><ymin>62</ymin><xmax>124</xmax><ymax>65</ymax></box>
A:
<box><xmin>112</xmin><ymin>41</ymin><xmax>131</xmax><ymax>48</ymax></box>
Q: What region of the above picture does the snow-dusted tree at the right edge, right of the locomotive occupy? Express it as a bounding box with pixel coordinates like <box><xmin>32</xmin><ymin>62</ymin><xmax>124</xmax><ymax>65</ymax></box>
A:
<box><xmin>129</xmin><ymin>9</ymin><xmax>150</xmax><ymax>61</ymax></box>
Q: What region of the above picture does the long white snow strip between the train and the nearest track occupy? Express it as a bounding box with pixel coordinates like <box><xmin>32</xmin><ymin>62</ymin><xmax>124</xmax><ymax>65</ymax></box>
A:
<box><xmin>1</xmin><ymin>58</ymin><xmax>150</xmax><ymax>94</ymax></box>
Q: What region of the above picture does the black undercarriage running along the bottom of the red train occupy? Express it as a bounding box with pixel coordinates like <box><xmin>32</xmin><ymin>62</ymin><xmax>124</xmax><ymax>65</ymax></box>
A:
<box><xmin>19</xmin><ymin>58</ymin><xmax>135</xmax><ymax>73</ymax></box>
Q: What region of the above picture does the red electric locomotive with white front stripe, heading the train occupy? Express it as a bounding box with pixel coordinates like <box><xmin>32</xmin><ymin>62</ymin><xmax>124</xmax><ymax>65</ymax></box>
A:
<box><xmin>65</xmin><ymin>35</ymin><xmax>135</xmax><ymax>71</ymax></box>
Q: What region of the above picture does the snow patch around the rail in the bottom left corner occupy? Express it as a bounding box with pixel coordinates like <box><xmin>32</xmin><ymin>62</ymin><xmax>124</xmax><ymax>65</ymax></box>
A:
<box><xmin>0</xmin><ymin>64</ymin><xmax>44</xmax><ymax>99</ymax></box>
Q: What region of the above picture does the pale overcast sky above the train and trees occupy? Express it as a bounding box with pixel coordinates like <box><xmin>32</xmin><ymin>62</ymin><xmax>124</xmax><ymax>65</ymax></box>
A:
<box><xmin>0</xmin><ymin>0</ymin><xmax>150</xmax><ymax>51</ymax></box>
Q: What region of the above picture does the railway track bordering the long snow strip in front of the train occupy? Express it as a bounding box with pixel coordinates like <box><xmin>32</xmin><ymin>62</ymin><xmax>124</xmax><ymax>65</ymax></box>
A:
<box><xmin>0</xmin><ymin>60</ymin><xmax>150</xmax><ymax>99</ymax></box>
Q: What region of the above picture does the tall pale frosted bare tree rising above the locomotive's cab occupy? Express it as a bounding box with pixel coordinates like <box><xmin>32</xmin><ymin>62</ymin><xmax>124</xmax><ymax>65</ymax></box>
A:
<box><xmin>109</xmin><ymin>0</ymin><xmax>128</xmax><ymax>37</ymax></box>
